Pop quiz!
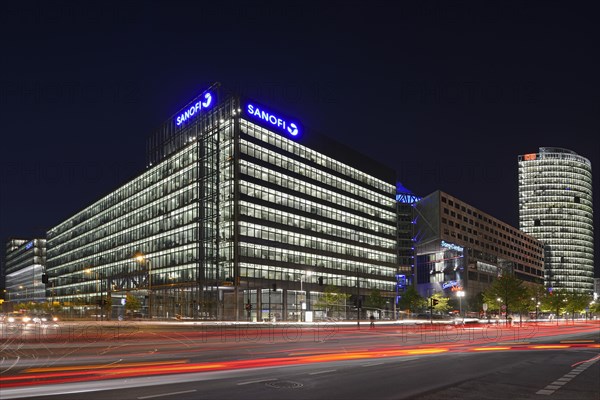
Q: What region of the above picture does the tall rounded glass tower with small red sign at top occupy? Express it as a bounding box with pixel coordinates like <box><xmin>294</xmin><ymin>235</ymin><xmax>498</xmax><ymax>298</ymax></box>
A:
<box><xmin>518</xmin><ymin>147</ymin><xmax>594</xmax><ymax>294</ymax></box>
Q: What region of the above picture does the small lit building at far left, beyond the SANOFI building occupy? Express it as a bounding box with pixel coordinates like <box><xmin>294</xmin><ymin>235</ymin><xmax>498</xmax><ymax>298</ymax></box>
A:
<box><xmin>4</xmin><ymin>239</ymin><xmax>46</xmax><ymax>303</ymax></box>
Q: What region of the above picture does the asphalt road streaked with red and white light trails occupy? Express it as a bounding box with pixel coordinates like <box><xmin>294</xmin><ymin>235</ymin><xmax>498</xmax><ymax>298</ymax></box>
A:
<box><xmin>0</xmin><ymin>325</ymin><xmax>600</xmax><ymax>400</ymax></box>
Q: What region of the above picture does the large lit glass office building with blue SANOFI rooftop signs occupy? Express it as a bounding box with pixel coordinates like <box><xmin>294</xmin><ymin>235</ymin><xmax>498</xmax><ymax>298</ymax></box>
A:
<box><xmin>48</xmin><ymin>85</ymin><xmax>398</xmax><ymax>320</ymax></box>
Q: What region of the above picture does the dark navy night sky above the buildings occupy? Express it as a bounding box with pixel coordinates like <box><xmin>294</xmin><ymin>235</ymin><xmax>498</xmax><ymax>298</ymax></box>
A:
<box><xmin>0</xmin><ymin>1</ymin><xmax>600</xmax><ymax>276</ymax></box>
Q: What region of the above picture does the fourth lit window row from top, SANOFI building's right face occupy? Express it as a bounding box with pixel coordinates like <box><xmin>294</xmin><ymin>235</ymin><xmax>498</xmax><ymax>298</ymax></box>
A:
<box><xmin>240</xmin><ymin>182</ymin><xmax>396</xmax><ymax>236</ymax></box>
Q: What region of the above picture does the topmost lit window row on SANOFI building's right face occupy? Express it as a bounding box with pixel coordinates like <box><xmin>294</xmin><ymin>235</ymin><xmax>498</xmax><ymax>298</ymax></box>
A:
<box><xmin>241</xmin><ymin>120</ymin><xmax>396</xmax><ymax>195</ymax></box>
